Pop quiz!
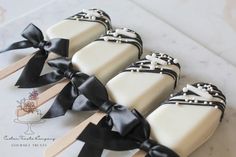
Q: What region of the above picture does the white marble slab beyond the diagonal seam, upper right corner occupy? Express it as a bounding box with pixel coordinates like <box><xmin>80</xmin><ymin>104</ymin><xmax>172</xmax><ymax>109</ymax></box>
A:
<box><xmin>132</xmin><ymin>0</ymin><xmax>236</xmax><ymax>65</ymax></box>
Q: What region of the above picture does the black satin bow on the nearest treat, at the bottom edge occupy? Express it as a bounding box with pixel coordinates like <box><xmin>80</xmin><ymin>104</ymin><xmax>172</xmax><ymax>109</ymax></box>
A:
<box><xmin>77</xmin><ymin>111</ymin><xmax>179</xmax><ymax>157</ymax></box>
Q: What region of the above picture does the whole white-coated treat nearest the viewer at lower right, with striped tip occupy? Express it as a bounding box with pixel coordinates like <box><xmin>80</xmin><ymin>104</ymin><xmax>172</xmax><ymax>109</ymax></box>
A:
<box><xmin>147</xmin><ymin>83</ymin><xmax>226</xmax><ymax>157</ymax></box>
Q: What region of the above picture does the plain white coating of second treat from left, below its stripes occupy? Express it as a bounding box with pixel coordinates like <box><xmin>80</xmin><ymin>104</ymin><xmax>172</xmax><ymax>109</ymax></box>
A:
<box><xmin>72</xmin><ymin>28</ymin><xmax>140</xmax><ymax>83</ymax></box>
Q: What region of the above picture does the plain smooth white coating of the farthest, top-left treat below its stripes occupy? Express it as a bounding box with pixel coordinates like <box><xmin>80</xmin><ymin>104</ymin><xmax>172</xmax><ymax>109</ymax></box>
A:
<box><xmin>47</xmin><ymin>20</ymin><xmax>106</xmax><ymax>56</ymax></box>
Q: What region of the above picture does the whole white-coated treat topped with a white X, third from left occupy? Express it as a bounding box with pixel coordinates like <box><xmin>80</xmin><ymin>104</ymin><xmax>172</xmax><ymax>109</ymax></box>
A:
<box><xmin>106</xmin><ymin>53</ymin><xmax>180</xmax><ymax>115</ymax></box>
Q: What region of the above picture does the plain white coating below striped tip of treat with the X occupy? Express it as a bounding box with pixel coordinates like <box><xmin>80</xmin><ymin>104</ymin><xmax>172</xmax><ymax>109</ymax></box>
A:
<box><xmin>106</xmin><ymin>52</ymin><xmax>180</xmax><ymax>115</ymax></box>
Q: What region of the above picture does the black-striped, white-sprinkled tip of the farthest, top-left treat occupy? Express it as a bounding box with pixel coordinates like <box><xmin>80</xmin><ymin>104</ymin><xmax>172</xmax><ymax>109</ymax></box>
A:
<box><xmin>67</xmin><ymin>9</ymin><xmax>112</xmax><ymax>30</ymax></box>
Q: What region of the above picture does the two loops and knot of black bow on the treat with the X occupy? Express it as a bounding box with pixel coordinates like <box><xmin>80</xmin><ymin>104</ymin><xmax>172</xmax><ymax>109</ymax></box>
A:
<box><xmin>79</xmin><ymin>76</ymin><xmax>139</xmax><ymax>135</ymax></box>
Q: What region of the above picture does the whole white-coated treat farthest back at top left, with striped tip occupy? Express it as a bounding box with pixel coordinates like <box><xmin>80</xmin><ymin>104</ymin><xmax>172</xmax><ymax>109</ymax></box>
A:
<box><xmin>46</xmin><ymin>9</ymin><xmax>111</xmax><ymax>56</ymax></box>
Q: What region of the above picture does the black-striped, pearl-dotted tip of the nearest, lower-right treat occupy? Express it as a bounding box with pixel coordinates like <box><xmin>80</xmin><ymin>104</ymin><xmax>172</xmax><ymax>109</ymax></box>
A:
<box><xmin>163</xmin><ymin>82</ymin><xmax>226</xmax><ymax>120</ymax></box>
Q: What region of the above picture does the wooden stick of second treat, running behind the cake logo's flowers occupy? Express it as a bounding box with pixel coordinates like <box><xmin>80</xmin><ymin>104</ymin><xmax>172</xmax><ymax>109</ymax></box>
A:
<box><xmin>16</xmin><ymin>80</ymin><xmax>69</xmax><ymax>116</ymax></box>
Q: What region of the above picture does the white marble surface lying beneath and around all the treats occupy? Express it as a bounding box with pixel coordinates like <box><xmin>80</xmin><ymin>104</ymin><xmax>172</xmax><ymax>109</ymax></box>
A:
<box><xmin>0</xmin><ymin>0</ymin><xmax>236</xmax><ymax>157</ymax></box>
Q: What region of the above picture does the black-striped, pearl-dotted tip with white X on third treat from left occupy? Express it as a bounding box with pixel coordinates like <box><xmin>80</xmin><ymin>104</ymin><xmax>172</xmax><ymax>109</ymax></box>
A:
<box><xmin>124</xmin><ymin>53</ymin><xmax>180</xmax><ymax>87</ymax></box>
